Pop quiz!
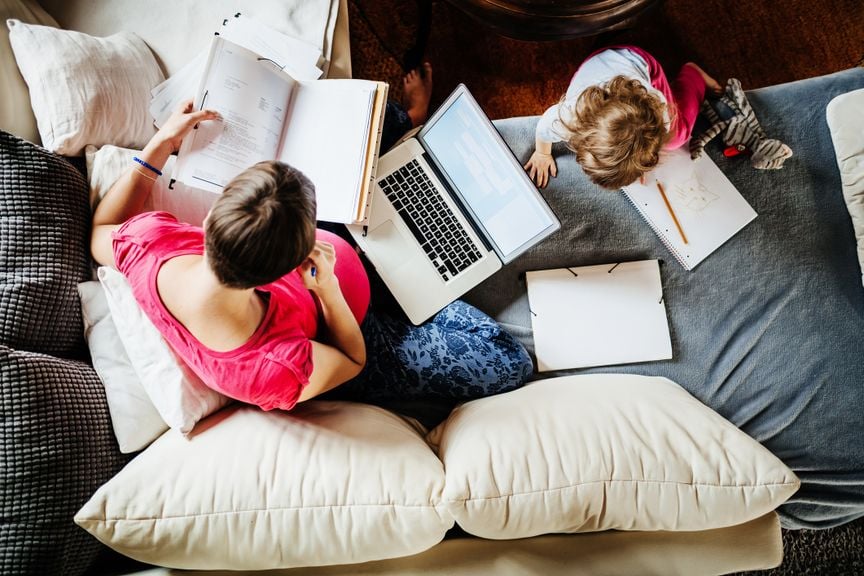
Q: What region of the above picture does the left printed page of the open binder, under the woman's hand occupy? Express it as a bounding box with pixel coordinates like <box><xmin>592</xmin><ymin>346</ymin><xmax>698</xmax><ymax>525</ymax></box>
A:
<box><xmin>176</xmin><ymin>36</ymin><xmax>296</xmax><ymax>192</ymax></box>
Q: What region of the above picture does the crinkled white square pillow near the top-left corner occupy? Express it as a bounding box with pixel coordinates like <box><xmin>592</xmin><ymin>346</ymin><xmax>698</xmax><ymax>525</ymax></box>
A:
<box><xmin>7</xmin><ymin>19</ymin><xmax>164</xmax><ymax>156</ymax></box>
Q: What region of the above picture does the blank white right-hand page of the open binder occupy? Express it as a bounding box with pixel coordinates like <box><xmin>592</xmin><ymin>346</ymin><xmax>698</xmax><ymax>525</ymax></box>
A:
<box><xmin>277</xmin><ymin>80</ymin><xmax>377</xmax><ymax>223</ymax></box>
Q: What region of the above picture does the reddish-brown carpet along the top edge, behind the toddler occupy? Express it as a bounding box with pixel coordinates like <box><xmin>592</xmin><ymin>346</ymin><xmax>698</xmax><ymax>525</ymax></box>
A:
<box><xmin>348</xmin><ymin>0</ymin><xmax>864</xmax><ymax>119</ymax></box>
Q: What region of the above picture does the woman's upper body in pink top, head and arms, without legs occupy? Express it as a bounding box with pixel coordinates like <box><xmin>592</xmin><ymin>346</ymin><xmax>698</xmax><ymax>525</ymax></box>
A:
<box><xmin>91</xmin><ymin>101</ymin><xmax>369</xmax><ymax>409</ymax></box>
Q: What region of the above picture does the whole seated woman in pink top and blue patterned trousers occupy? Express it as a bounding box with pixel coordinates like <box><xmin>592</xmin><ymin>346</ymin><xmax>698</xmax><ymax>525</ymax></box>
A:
<box><xmin>91</xmin><ymin>80</ymin><xmax>532</xmax><ymax>410</ymax></box>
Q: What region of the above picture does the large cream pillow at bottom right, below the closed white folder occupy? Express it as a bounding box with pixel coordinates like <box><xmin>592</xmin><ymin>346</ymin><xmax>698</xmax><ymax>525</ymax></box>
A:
<box><xmin>430</xmin><ymin>374</ymin><xmax>799</xmax><ymax>539</ymax></box>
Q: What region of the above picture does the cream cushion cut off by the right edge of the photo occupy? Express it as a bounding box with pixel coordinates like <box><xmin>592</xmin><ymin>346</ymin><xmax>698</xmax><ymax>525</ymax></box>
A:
<box><xmin>826</xmin><ymin>89</ymin><xmax>864</xmax><ymax>282</ymax></box>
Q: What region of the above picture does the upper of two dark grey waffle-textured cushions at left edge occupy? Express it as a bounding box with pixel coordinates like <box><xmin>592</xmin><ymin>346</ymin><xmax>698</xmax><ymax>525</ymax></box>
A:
<box><xmin>0</xmin><ymin>131</ymin><xmax>90</xmax><ymax>358</ymax></box>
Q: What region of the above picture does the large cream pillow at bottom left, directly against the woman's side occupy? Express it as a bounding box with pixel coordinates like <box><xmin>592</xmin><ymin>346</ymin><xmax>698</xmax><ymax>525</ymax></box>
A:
<box><xmin>75</xmin><ymin>401</ymin><xmax>453</xmax><ymax>570</ymax></box>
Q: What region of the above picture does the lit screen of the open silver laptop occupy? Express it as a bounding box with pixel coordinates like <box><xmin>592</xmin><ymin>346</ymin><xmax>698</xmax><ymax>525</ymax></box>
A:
<box><xmin>418</xmin><ymin>87</ymin><xmax>559</xmax><ymax>263</ymax></box>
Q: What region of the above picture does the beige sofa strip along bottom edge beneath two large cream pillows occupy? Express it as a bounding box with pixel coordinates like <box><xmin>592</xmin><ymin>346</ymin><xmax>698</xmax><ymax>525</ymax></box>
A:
<box><xmin>121</xmin><ymin>512</ymin><xmax>783</xmax><ymax>576</ymax></box>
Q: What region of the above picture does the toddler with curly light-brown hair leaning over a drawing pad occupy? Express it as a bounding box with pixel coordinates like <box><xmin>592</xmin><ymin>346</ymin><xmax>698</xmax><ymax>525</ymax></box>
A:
<box><xmin>525</xmin><ymin>46</ymin><xmax>722</xmax><ymax>189</ymax></box>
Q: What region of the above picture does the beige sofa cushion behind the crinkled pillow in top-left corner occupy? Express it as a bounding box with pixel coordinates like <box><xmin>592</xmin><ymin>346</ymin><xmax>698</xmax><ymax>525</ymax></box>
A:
<box><xmin>0</xmin><ymin>0</ymin><xmax>57</xmax><ymax>144</ymax></box>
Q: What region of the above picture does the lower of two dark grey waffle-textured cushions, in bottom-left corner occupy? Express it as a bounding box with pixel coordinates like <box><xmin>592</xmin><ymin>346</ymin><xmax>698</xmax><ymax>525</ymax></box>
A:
<box><xmin>0</xmin><ymin>345</ymin><xmax>125</xmax><ymax>576</ymax></box>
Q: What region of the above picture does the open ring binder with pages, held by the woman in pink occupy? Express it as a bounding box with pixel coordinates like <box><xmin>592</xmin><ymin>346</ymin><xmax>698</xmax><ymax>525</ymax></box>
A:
<box><xmin>175</xmin><ymin>36</ymin><xmax>387</xmax><ymax>224</ymax></box>
